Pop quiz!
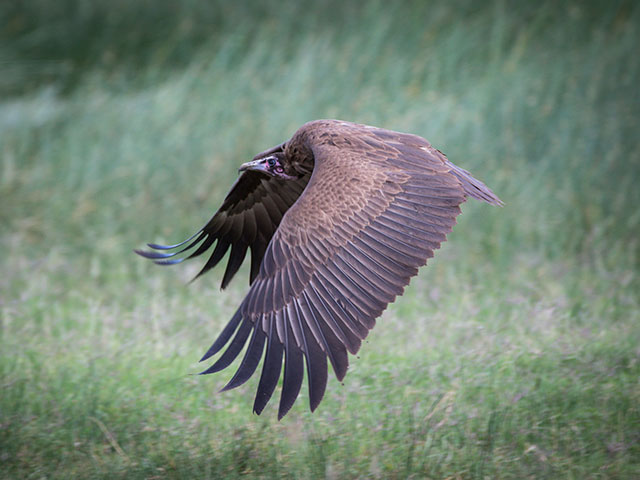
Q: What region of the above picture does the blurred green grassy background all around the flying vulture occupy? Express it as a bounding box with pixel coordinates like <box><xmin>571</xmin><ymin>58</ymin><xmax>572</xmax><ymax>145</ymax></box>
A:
<box><xmin>0</xmin><ymin>0</ymin><xmax>640</xmax><ymax>479</ymax></box>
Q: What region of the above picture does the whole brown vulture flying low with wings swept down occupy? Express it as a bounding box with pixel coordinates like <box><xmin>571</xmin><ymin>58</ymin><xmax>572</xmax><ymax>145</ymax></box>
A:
<box><xmin>136</xmin><ymin>120</ymin><xmax>502</xmax><ymax>419</ymax></box>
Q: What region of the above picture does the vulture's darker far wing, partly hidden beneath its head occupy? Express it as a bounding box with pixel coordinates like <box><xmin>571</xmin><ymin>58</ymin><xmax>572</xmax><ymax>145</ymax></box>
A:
<box><xmin>136</xmin><ymin>171</ymin><xmax>309</xmax><ymax>288</ymax></box>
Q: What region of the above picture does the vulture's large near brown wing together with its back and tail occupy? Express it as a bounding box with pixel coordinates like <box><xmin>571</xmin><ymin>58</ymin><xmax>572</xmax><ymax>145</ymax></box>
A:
<box><xmin>202</xmin><ymin>122</ymin><xmax>500</xmax><ymax>418</ymax></box>
